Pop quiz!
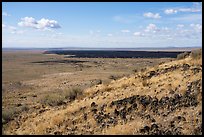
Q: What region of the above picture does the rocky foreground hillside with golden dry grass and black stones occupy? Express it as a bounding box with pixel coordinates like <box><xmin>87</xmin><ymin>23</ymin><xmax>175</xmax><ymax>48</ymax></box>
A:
<box><xmin>4</xmin><ymin>51</ymin><xmax>202</xmax><ymax>135</ymax></box>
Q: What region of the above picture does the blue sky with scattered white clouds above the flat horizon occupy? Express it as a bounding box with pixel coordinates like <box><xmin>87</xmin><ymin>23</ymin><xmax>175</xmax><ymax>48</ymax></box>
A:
<box><xmin>2</xmin><ymin>2</ymin><xmax>202</xmax><ymax>48</ymax></box>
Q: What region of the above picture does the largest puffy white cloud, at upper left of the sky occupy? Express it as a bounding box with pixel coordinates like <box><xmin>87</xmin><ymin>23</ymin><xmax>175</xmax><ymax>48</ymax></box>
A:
<box><xmin>18</xmin><ymin>17</ymin><xmax>60</xmax><ymax>30</ymax></box>
